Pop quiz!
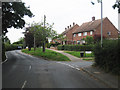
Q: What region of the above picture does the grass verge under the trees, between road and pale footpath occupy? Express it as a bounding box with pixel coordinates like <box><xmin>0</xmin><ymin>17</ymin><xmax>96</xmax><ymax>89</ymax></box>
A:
<box><xmin>22</xmin><ymin>48</ymin><xmax>70</xmax><ymax>61</ymax></box>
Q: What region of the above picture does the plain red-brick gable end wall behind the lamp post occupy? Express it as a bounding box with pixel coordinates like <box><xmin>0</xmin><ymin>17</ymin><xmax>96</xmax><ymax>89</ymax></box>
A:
<box><xmin>94</xmin><ymin>18</ymin><xmax>118</xmax><ymax>38</ymax></box>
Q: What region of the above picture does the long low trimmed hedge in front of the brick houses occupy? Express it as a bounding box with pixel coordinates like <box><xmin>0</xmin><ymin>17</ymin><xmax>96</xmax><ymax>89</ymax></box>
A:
<box><xmin>57</xmin><ymin>45</ymin><xmax>93</xmax><ymax>51</ymax></box>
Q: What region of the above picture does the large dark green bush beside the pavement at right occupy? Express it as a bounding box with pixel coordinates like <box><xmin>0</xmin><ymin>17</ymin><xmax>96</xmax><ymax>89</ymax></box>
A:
<box><xmin>93</xmin><ymin>40</ymin><xmax>120</xmax><ymax>74</ymax></box>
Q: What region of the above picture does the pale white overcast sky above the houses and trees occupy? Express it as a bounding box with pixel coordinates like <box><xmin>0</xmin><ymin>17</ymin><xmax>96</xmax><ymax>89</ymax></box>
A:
<box><xmin>7</xmin><ymin>0</ymin><xmax>118</xmax><ymax>43</ymax></box>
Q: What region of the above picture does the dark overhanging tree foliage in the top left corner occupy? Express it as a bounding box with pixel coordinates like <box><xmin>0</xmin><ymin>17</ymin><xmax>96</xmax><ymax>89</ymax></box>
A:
<box><xmin>2</xmin><ymin>2</ymin><xmax>33</xmax><ymax>35</ymax></box>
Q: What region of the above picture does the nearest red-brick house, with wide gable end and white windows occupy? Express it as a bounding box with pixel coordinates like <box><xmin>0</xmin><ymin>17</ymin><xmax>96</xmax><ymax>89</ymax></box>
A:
<box><xmin>73</xmin><ymin>17</ymin><xmax>118</xmax><ymax>44</ymax></box>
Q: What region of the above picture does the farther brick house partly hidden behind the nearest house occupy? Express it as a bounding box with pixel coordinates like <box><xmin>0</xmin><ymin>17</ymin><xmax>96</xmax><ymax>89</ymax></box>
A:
<box><xmin>61</xmin><ymin>22</ymin><xmax>79</xmax><ymax>44</ymax></box>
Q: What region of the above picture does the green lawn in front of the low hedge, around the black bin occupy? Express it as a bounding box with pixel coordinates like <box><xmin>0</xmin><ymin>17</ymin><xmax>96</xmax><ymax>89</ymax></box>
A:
<box><xmin>64</xmin><ymin>51</ymin><xmax>94</xmax><ymax>61</ymax></box>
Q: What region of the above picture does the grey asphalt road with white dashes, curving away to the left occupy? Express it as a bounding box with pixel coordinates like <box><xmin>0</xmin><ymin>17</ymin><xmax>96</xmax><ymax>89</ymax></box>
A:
<box><xmin>2</xmin><ymin>50</ymin><xmax>107</xmax><ymax>88</ymax></box>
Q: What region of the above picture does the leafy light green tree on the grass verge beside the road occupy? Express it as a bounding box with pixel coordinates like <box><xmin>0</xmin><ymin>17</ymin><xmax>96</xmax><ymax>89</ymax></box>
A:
<box><xmin>24</xmin><ymin>23</ymin><xmax>56</xmax><ymax>52</ymax></box>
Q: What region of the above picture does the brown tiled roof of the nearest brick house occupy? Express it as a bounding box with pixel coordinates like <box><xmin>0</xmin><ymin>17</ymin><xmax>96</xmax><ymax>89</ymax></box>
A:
<box><xmin>73</xmin><ymin>17</ymin><xmax>107</xmax><ymax>33</ymax></box>
